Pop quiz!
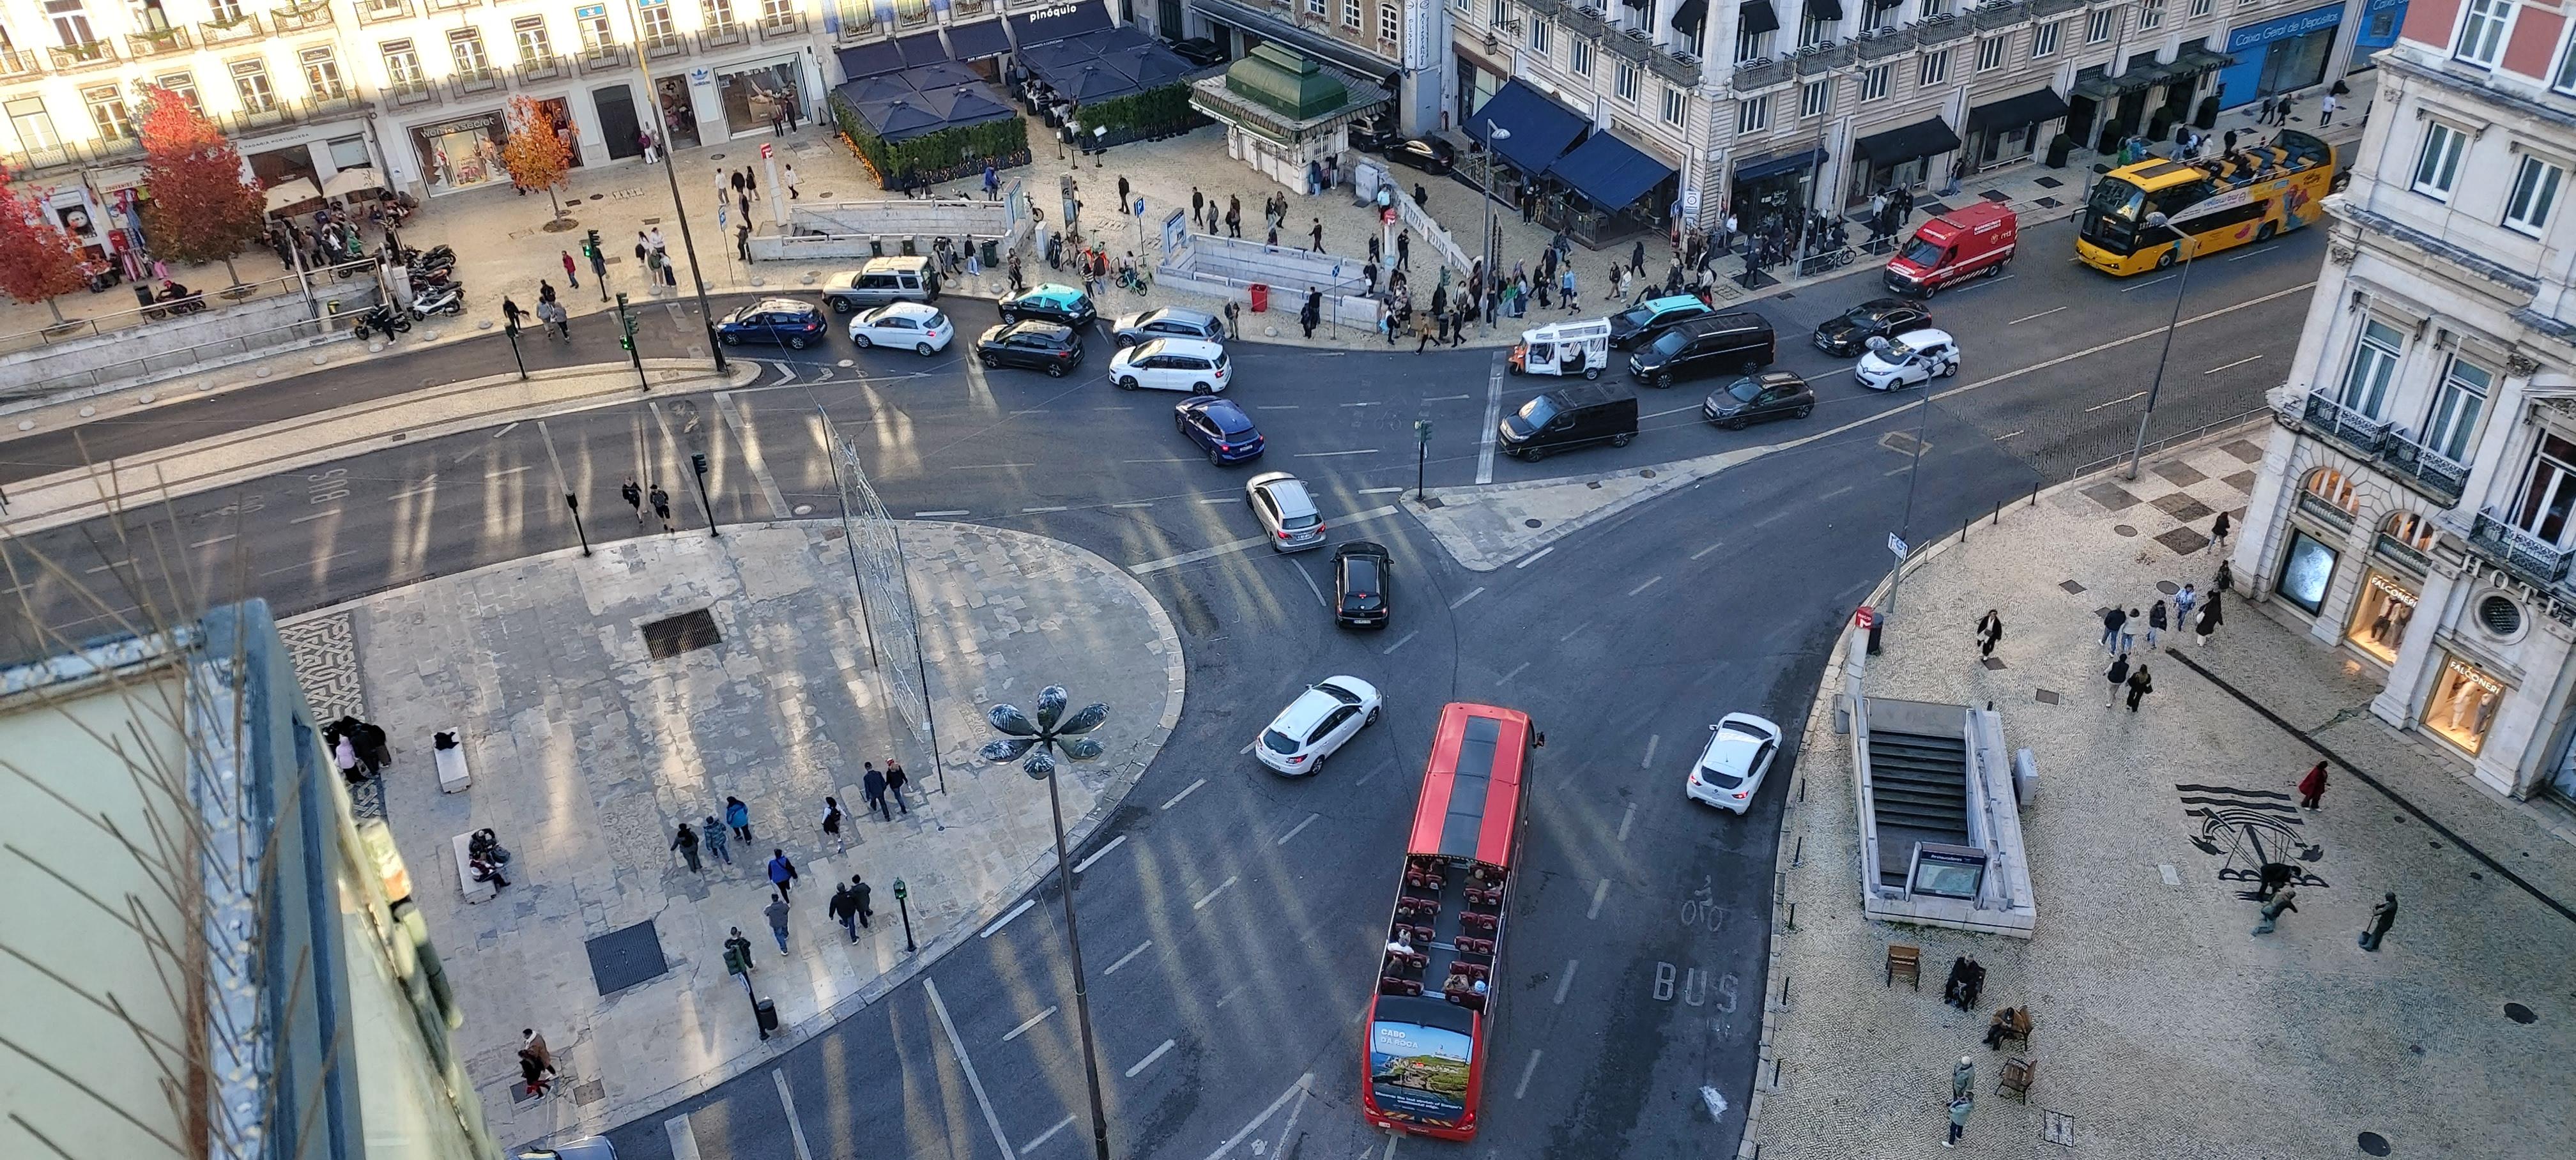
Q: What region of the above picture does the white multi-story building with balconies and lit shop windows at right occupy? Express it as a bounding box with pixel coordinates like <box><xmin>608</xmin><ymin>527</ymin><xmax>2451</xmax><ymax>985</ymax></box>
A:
<box><xmin>2234</xmin><ymin>0</ymin><xmax>2576</xmax><ymax>797</ymax></box>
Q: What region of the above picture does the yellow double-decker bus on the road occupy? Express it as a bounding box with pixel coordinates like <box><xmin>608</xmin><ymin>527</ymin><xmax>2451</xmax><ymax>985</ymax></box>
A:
<box><xmin>2076</xmin><ymin>129</ymin><xmax>2334</xmax><ymax>276</ymax></box>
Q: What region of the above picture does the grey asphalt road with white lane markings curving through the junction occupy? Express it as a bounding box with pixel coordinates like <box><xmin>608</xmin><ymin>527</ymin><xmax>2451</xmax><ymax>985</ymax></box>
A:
<box><xmin>0</xmin><ymin>212</ymin><xmax>2324</xmax><ymax>1160</ymax></box>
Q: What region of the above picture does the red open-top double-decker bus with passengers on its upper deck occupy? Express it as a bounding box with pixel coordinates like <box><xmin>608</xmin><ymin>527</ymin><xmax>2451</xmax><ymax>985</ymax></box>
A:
<box><xmin>1360</xmin><ymin>704</ymin><xmax>1535</xmax><ymax>1140</ymax></box>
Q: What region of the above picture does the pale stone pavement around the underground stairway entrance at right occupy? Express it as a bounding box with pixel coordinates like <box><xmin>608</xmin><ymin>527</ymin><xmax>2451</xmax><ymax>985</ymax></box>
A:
<box><xmin>1744</xmin><ymin>431</ymin><xmax>2576</xmax><ymax>1160</ymax></box>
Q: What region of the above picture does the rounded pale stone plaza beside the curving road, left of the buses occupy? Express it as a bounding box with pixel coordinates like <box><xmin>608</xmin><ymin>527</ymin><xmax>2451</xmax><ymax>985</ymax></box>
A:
<box><xmin>286</xmin><ymin>523</ymin><xmax>1183</xmax><ymax>1140</ymax></box>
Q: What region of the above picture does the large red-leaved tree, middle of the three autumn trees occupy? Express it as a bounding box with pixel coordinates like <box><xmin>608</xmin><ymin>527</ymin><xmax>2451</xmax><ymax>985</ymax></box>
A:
<box><xmin>142</xmin><ymin>85</ymin><xmax>268</xmax><ymax>286</ymax></box>
